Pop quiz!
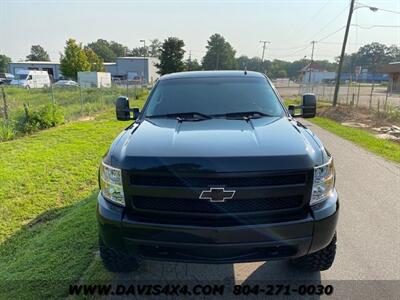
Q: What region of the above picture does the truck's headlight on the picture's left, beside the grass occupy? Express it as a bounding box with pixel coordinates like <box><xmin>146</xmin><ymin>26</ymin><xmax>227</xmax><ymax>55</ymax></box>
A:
<box><xmin>100</xmin><ymin>162</ymin><xmax>125</xmax><ymax>206</ymax></box>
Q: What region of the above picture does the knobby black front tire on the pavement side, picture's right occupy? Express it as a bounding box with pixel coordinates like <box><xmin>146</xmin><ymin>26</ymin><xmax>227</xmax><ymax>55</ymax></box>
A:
<box><xmin>291</xmin><ymin>233</ymin><xmax>336</xmax><ymax>271</ymax></box>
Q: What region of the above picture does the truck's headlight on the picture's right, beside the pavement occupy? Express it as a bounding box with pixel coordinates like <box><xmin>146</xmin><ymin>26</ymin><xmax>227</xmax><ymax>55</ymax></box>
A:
<box><xmin>310</xmin><ymin>157</ymin><xmax>335</xmax><ymax>205</ymax></box>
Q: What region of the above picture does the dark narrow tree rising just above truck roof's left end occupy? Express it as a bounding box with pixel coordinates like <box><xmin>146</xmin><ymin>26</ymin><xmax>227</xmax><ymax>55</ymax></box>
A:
<box><xmin>156</xmin><ymin>37</ymin><xmax>185</xmax><ymax>75</ymax></box>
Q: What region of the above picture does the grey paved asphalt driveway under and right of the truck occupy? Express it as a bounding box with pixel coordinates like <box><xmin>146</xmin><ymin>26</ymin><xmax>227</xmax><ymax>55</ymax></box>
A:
<box><xmin>111</xmin><ymin>121</ymin><xmax>400</xmax><ymax>299</ymax></box>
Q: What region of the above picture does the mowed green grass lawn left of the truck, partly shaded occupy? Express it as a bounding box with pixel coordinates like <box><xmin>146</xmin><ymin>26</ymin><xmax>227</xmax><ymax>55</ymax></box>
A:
<box><xmin>0</xmin><ymin>101</ymin><xmax>143</xmax><ymax>299</ymax></box>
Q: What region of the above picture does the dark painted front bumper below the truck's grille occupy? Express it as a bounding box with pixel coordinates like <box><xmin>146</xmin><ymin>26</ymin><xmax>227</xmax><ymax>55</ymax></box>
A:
<box><xmin>97</xmin><ymin>192</ymin><xmax>339</xmax><ymax>263</ymax></box>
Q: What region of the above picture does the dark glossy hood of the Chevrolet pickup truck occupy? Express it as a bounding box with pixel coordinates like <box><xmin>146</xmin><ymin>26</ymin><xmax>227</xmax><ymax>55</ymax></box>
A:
<box><xmin>109</xmin><ymin>117</ymin><xmax>322</xmax><ymax>172</ymax></box>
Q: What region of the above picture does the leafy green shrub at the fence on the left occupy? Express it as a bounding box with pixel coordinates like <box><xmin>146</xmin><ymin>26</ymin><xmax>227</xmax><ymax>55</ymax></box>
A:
<box><xmin>17</xmin><ymin>104</ymin><xmax>64</xmax><ymax>133</ymax></box>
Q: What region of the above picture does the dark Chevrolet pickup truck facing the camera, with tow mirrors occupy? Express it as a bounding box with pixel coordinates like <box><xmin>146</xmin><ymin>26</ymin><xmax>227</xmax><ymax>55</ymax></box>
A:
<box><xmin>97</xmin><ymin>71</ymin><xmax>339</xmax><ymax>272</ymax></box>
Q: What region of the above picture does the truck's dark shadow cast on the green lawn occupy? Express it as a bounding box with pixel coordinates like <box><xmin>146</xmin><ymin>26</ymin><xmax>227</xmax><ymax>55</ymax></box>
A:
<box><xmin>0</xmin><ymin>191</ymin><xmax>101</xmax><ymax>299</ymax></box>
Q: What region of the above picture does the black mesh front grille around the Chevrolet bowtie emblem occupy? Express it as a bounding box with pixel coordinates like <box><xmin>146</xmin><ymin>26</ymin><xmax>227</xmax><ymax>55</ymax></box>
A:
<box><xmin>123</xmin><ymin>170</ymin><xmax>313</xmax><ymax>226</ymax></box>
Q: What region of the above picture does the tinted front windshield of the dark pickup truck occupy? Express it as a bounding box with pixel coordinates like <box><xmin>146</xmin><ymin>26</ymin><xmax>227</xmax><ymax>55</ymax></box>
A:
<box><xmin>145</xmin><ymin>77</ymin><xmax>284</xmax><ymax>117</ymax></box>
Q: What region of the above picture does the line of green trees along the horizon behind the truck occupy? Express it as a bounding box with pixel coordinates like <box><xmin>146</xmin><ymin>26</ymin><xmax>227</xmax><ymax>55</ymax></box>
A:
<box><xmin>0</xmin><ymin>33</ymin><xmax>400</xmax><ymax>79</ymax></box>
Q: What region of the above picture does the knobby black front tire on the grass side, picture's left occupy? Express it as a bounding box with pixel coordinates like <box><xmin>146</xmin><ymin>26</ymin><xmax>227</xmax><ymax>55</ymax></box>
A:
<box><xmin>99</xmin><ymin>238</ymin><xmax>140</xmax><ymax>273</ymax></box>
